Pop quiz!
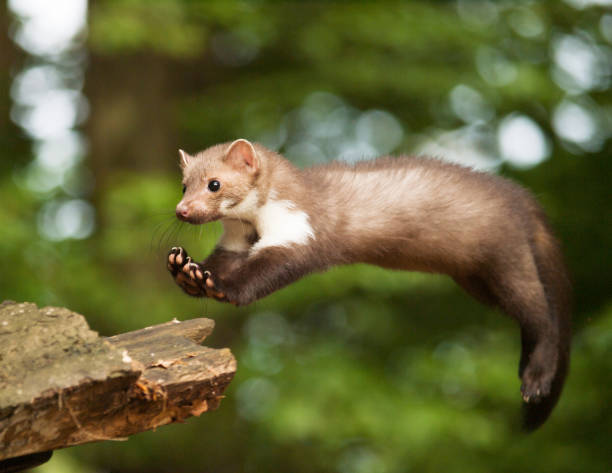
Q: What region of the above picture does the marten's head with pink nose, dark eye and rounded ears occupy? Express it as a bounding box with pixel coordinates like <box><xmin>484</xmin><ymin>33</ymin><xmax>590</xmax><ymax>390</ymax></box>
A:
<box><xmin>176</xmin><ymin>139</ymin><xmax>261</xmax><ymax>224</ymax></box>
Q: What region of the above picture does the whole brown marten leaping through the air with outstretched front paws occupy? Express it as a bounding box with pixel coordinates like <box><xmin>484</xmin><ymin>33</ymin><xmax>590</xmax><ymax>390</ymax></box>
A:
<box><xmin>168</xmin><ymin>139</ymin><xmax>571</xmax><ymax>430</ymax></box>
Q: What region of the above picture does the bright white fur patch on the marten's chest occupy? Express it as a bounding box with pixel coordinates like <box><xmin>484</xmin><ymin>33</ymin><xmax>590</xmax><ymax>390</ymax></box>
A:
<box><xmin>252</xmin><ymin>199</ymin><xmax>315</xmax><ymax>252</ymax></box>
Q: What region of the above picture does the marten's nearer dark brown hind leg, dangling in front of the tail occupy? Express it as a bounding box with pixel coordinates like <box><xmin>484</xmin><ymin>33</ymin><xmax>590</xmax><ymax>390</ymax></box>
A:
<box><xmin>491</xmin><ymin>253</ymin><xmax>559</xmax><ymax>402</ymax></box>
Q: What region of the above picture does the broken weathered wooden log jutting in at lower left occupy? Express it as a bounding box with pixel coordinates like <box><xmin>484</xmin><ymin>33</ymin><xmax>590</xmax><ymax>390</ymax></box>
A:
<box><xmin>0</xmin><ymin>303</ymin><xmax>236</xmax><ymax>460</ymax></box>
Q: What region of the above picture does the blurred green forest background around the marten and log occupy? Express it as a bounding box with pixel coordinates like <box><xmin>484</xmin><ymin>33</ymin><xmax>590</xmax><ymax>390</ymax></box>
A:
<box><xmin>0</xmin><ymin>0</ymin><xmax>612</xmax><ymax>473</ymax></box>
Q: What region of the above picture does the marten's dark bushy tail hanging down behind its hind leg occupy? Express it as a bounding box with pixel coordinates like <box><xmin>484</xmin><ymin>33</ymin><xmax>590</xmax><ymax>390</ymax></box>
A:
<box><xmin>520</xmin><ymin>212</ymin><xmax>572</xmax><ymax>431</ymax></box>
